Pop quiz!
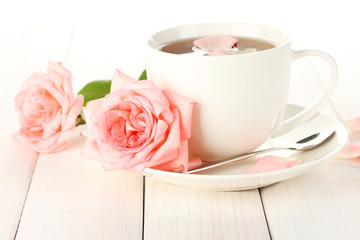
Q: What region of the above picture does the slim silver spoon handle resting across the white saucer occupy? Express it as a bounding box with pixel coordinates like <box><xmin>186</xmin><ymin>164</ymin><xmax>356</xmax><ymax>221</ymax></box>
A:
<box><xmin>187</xmin><ymin>147</ymin><xmax>285</xmax><ymax>174</ymax></box>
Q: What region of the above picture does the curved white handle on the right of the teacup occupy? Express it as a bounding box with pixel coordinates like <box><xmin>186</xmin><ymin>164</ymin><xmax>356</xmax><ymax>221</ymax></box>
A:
<box><xmin>272</xmin><ymin>50</ymin><xmax>338</xmax><ymax>137</ymax></box>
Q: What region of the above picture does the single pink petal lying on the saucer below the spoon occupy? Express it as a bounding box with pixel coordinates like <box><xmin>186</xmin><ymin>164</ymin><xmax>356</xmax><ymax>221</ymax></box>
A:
<box><xmin>245</xmin><ymin>156</ymin><xmax>300</xmax><ymax>174</ymax></box>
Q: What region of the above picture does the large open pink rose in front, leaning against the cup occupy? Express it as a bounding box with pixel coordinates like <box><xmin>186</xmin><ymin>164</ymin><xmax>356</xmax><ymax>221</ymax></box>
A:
<box><xmin>82</xmin><ymin>70</ymin><xmax>201</xmax><ymax>173</ymax></box>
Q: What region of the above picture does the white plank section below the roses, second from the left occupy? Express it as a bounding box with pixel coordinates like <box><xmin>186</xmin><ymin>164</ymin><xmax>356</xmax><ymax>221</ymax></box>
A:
<box><xmin>16</xmin><ymin>129</ymin><xmax>143</xmax><ymax>240</ymax></box>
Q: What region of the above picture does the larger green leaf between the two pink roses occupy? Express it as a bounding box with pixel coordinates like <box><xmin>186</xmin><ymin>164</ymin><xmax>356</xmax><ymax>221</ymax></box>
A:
<box><xmin>78</xmin><ymin>80</ymin><xmax>111</xmax><ymax>107</ymax></box>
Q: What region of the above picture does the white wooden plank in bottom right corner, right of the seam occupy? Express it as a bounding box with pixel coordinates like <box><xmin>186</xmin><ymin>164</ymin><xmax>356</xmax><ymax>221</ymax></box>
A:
<box><xmin>261</xmin><ymin>158</ymin><xmax>360</xmax><ymax>240</ymax></box>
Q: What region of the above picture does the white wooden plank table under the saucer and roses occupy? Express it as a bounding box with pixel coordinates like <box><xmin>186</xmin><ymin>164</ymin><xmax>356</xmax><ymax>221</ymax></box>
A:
<box><xmin>0</xmin><ymin>2</ymin><xmax>360</xmax><ymax>240</ymax></box>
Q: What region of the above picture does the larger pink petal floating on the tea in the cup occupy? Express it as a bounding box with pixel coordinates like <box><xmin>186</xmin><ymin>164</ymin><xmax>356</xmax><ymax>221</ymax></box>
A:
<box><xmin>193</xmin><ymin>36</ymin><xmax>238</xmax><ymax>51</ymax></box>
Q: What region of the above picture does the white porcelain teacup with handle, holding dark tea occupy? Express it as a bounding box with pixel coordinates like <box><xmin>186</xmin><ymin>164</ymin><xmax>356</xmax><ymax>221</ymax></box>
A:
<box><xmin>145</xmin><ymin>23</ymin><xmax>337</xmax><ymax>161</ymax></box>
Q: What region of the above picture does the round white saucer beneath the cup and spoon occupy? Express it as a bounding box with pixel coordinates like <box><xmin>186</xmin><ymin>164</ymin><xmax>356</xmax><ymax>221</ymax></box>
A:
<box><xmin>144</xmin><ymin>104</ymin><xmax>348</xmax><ymax>191</ymax></box>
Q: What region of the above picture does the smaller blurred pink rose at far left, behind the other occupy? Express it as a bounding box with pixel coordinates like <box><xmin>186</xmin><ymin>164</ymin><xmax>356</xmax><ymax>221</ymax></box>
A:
<box><xmin>14</xmin><ymin>62</ymin><xmax>84</xmax><ymax>153</ymax></box>
